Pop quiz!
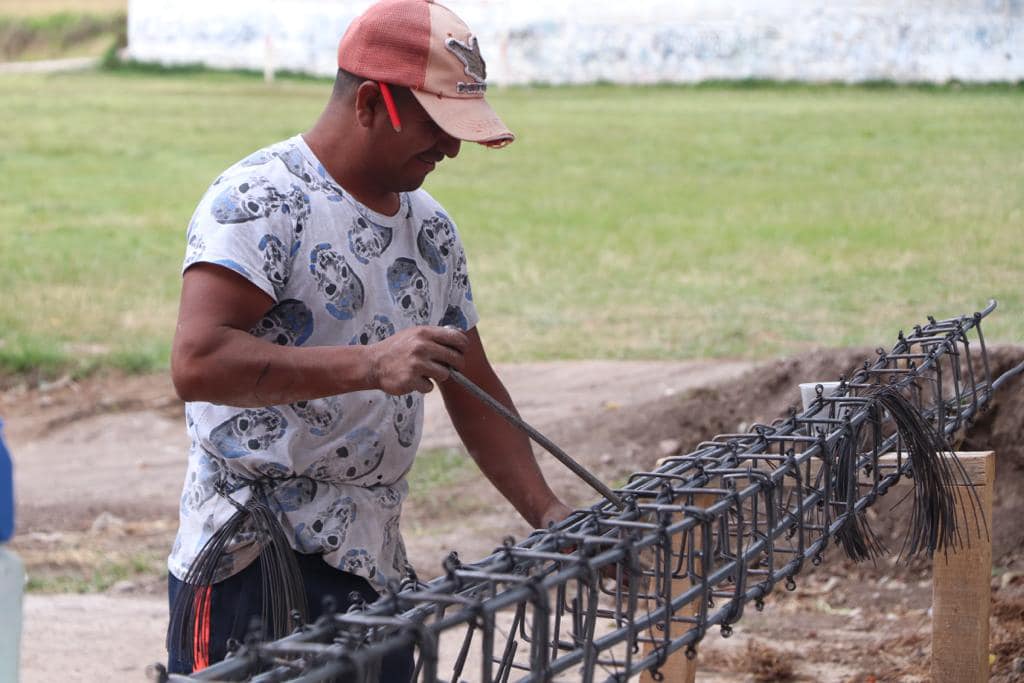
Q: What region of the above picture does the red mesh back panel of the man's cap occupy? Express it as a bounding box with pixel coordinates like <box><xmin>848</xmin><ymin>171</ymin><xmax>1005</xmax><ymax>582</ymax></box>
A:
<box><xmin>338</xmin><ymin>0</ymin><xmax>430</xmax><ymax>88</ymax></box>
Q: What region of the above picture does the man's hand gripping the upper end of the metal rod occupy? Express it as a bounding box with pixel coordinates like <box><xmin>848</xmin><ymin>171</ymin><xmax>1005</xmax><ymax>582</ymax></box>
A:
<box><xmin>367</xmin><ymin>327</ymin><xmax>469</xmax><ymax>395</ymax></box>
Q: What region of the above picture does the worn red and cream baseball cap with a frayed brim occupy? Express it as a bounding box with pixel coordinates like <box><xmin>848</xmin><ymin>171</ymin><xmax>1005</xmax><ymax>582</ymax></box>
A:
<box><xmin>338</xmin><ymin>0</ymin><xmax>515</xmax><ymax>147</ymax></box>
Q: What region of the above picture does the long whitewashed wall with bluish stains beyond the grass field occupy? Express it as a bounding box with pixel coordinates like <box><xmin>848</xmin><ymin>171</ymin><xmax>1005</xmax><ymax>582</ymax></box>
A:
<box><xmin>128</xmin><ymin>0</ymin><xmax>1024</xmax><ymax>84</ymax></box>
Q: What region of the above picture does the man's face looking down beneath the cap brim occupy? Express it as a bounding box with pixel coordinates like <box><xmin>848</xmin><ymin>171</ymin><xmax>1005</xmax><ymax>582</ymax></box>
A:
<box><xmin>375</xmin><ymin>88</ymin><xmax>462</xmax><ymax>191</ymax></box>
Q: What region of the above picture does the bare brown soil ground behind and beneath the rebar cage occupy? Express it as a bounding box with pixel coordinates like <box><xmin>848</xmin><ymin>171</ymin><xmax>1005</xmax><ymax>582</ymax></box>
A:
<box><xmin>0</xmin><ymin>347</ymin><xmax>1024</xmax><ymax>683</ymax></box>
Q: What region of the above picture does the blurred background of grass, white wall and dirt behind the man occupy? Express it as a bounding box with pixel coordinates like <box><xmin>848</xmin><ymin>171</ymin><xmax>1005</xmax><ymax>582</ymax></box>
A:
<box><xmin>0</xmin><ymin>0</ymin><xmax>1024</xmax><ymax>681</ymax></box>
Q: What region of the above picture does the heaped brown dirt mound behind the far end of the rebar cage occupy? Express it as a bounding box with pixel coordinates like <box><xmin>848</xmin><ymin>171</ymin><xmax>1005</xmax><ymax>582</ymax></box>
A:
<box><xmin>559</xmin><ymin>346</ymin><xmax>1024</xmax><ymax>564</ymax></box>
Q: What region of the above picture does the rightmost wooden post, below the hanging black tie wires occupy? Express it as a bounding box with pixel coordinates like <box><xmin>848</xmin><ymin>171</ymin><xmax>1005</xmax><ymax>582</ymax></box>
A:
<box><xmin>932</xmin><ymin>451</ymin><xmax>995</xmax><ymax>683</ymax></box>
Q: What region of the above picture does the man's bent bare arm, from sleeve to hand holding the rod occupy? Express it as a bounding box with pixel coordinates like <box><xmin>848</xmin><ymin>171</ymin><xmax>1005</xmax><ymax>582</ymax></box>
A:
<box><xmin>171</xmin><ymin>263</ymin><xmax>468</xmax><ymax>408</ymax></box>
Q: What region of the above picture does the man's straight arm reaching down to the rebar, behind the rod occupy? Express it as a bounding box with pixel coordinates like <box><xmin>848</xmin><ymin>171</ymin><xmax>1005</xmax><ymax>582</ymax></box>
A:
<box><xmin>439</xmin><ymin>328</ymin><xmax>572</xmax><ymax>528</ymax></box>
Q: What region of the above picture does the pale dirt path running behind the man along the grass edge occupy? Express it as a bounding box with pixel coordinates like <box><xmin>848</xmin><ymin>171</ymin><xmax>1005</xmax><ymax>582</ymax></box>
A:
<box><xmin>0</xmin><ymin>361</ymin><xmax>751</xmax><ymax>532</ymax></box>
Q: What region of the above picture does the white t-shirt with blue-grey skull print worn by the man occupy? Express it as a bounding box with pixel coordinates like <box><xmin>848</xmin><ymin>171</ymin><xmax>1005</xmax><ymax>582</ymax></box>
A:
<box><xmin>168</xmin><ymin>135</ymin><xmax>477</xmax><ymax>589</ymax></box>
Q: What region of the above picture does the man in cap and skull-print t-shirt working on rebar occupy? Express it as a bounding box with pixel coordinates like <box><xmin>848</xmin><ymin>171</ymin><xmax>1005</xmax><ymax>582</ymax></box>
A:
<box><xmin>168</xmin><ymin>0</ymin><xmax>569</xmax><ymax>680</ymax></box>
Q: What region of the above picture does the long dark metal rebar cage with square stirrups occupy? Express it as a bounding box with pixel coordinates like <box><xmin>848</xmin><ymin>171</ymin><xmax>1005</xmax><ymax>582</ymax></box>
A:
<box><xmin>161</xmin><ymin>302</ymin><xmax>997</xmax><ymax>683</ymax></box>
